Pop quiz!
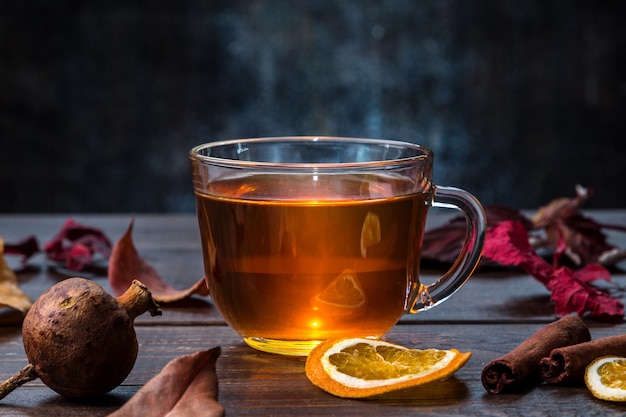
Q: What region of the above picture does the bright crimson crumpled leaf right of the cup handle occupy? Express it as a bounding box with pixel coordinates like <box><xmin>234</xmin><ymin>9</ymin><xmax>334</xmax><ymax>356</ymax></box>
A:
<box><xmin>483</xmin><ymin>221</ymin><xmax>624</xmax><ymax>321</ymax></box>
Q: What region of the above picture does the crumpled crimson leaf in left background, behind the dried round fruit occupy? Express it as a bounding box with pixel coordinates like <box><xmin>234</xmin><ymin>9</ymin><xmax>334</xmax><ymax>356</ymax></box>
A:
<box><xmin>44</xmin><ymin>219</ymin><xmax>111</xmax><ymax>271</ymax></box>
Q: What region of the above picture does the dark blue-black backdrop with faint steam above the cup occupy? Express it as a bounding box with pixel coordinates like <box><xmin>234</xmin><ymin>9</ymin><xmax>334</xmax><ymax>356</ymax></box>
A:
<box><xmin>0</xmin><ymin>0</ymin><xmax>626</xmax><ymax>212</ymax></box>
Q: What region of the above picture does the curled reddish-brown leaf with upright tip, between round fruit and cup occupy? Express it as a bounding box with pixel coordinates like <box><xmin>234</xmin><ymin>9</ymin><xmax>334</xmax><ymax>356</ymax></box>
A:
<box><xmin>108</xmin><ymin>220</ymin><xmax>209</xmax><ymax>303</ymax></box>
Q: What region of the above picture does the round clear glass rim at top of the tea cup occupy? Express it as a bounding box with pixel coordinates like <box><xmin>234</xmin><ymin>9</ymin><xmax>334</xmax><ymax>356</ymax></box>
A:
<box><xmin>189</xmin><ymin>136</ymin><xmax>433</xmax><ymax>169</ymax></box>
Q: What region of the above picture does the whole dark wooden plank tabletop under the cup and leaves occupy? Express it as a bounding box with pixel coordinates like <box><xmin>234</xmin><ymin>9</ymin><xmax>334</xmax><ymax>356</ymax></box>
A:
<box><xmin>0</xmin><ymin>210</ymin><xmax>626</xmax><ymax>417</ymax></box>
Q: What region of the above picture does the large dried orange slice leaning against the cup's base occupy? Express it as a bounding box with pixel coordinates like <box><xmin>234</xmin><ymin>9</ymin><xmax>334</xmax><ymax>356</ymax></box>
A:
<box><xmin>306</xmin><ymin>338</ymin><xmax>472</xmax><ymax>398</ymax></box>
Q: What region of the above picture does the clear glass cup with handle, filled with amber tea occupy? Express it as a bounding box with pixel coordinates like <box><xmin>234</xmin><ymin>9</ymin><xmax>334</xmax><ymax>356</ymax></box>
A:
<box><xmin>189</xmin><ymin>137</ymin><xmax>486</xmax><ymax>355</ymax></box>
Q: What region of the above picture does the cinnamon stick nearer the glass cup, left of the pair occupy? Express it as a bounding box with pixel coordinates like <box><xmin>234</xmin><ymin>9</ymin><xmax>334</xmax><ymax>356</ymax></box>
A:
<box><xmin>482</xmin><ymin>315</ymin><xmax>591</xmax><ymax>394</ymax></box>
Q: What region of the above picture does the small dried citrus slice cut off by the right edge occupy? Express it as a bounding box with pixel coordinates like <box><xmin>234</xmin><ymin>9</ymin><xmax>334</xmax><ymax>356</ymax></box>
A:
<box><xmin>585</xmin><ymin>356</ymin><xmax>626</xmax><ymax>401</ymax></box>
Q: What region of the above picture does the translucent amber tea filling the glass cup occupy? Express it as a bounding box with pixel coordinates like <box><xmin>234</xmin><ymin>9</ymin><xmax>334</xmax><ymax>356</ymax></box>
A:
<box><xmin>196</xmin><ymin>175</ymin><xmax>427</xmax><ymax>355</ymax></box>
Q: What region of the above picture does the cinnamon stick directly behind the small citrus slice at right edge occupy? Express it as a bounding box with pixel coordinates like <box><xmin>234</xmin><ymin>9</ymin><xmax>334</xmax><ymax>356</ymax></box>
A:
<box><xmin>539</xmin><ymin>334</ymin><xmax>626</xmax><ymax>384</ymax></box>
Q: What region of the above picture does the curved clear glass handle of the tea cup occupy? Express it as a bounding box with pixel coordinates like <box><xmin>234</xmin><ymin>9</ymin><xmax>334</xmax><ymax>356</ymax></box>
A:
<box><xmin>408</xmin><ymin>186</ymin><xmax>487</xmax><ymax>313</ymax></box>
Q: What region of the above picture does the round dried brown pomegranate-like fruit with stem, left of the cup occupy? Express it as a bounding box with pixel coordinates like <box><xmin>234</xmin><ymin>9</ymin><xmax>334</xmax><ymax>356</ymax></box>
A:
<box><xmin>0</xmin><ymin>278</ymin><xmax>161</xmax><ymax>398</ymax></box>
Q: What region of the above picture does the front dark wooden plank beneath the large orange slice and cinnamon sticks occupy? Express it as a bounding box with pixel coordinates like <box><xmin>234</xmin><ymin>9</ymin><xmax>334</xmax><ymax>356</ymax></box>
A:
<box><xmin>0</xmin><ymin>324</ymin><xmax>626</xmax><ymax>417</ymax></box>
